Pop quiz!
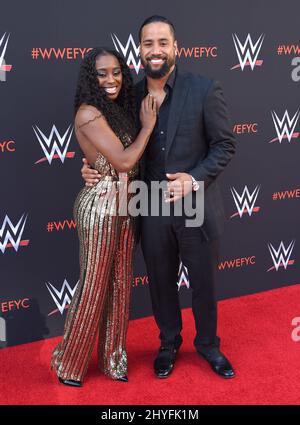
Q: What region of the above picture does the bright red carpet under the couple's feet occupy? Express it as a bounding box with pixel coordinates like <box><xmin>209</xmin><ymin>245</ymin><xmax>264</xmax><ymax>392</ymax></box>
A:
<box><xmin>0</xmin><ymin>284</ymin><xmax>300</xmax><ymax>405</ymax></box>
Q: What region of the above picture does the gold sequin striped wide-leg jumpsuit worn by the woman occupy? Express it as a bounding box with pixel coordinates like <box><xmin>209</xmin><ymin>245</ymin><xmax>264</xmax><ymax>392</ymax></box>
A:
<box><xmin>51</xmin><ymin>134</ymin><xmax>137</xmax><ymax>382</ymax></box>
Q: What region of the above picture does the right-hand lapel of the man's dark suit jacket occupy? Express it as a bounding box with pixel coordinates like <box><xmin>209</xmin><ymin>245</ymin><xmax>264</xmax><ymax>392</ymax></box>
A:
<box><xmin>166</xmin><ymin>70</ymin><xmax>189</xmax><ymax>157</ymax></box>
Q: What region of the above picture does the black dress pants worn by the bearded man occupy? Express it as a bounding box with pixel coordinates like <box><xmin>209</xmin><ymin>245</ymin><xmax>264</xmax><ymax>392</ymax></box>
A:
<box><xmin>141</xmin><ymin>203</ymin><xmax>220</xmax><ymax>352</ymax></box>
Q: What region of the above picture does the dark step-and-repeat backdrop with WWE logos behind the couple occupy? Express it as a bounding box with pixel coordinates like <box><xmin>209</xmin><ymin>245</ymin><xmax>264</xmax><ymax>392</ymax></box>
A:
<box><xmin>0</xmin><ymin>0</ymin><xmax>300</xmax><ymax>347</ymax></box>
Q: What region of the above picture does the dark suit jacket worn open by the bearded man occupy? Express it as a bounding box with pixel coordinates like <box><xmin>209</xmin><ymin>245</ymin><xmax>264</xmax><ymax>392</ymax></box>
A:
<box><xmin>135</xmin><ymin>67</ymin><xmax>236</xmax><ymax>240</ymax></box>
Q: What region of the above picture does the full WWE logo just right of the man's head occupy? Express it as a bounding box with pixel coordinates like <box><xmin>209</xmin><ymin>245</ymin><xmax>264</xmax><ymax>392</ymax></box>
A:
<box><xmin>231</xmin><ymin>34</ymin><xmax>265</xmax><ymax>71</ymax></box>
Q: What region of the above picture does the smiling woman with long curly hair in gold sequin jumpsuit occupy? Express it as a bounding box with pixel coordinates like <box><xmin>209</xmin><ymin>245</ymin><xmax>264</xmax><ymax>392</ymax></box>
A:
<box><xmin>51</xmin><ymin>48</ymin><xmax>156</xmax><ymax>386</ymax></box>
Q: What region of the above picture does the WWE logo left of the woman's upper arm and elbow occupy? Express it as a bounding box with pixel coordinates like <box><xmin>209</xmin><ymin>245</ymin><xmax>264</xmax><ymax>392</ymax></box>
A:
<box><xmin>32</xmin><ymin>125</ymin><xmax>75</xmax><ymax>164</ymax></box>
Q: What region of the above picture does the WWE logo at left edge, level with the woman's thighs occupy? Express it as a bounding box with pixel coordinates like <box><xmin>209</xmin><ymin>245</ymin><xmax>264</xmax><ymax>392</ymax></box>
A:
<box><xmin>0</xmin><ymin>214</ymin><xmax>29</xmax><ymax>254</ymax></box>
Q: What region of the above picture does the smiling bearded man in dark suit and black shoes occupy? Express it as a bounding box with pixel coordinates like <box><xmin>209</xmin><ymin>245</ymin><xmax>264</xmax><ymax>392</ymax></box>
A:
<box><xmin>82</xmin><ymin>16</ymin><xmax>236</xmax><ymax>378</ymax></box>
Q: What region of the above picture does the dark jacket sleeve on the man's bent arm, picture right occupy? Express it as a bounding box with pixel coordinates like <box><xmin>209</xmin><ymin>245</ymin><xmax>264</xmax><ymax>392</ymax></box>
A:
<box><xmin>189</xmin><ymin>81</ymin><xmax>236</xmax><ymax>188</ymax></box>
